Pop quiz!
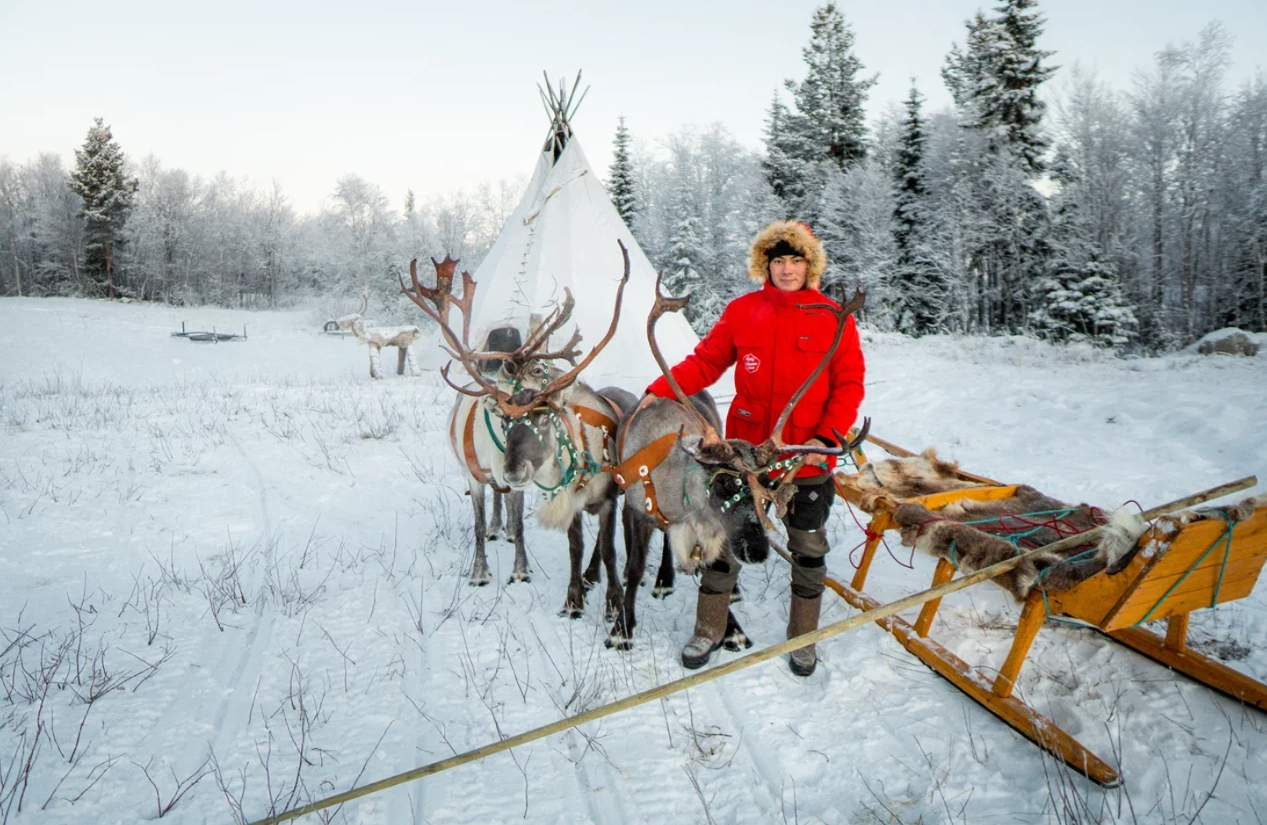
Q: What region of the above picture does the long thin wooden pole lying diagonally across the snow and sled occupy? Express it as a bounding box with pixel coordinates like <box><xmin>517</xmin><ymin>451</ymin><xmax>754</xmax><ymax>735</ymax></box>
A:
<box><xmin>251</xmin><ymin>475</ymin><xmax>1258</xmax><ymax>825</ymax></box>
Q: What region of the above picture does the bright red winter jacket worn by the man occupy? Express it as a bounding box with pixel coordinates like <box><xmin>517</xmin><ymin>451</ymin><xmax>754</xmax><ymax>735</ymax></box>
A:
<box><xmin>646</xmin><ymin>283</ymin><xmax>867</xmax><ymax>478</ymax></box>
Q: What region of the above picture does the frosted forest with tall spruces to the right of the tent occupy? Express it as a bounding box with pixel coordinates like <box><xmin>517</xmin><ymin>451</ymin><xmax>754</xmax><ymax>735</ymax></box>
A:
<box><xmin>609</xmin><ymin>0</ymin><xmax>1267</xmax><ymax>352</ymax></box>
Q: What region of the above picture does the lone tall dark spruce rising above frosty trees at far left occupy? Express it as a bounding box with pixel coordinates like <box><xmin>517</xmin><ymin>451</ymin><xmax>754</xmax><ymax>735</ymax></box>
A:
<box><xmin>71</xmin><ymin>118</ymin><xmax>137</xmax><ymax>298</ymax></box>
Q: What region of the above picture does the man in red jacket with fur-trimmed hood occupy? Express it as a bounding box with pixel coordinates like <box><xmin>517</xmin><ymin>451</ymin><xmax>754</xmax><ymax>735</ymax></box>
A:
<box><xmin>644</xmin><ymin>221</ymin><xmax>865</xmax><ymax>675</ymax></box>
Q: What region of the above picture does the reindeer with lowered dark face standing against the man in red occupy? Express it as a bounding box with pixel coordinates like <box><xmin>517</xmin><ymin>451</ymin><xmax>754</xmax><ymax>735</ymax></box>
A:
<box><xmin>607</xmin><ymin>278</ymin><xmax>870</xmax><ymax>650</ymax></box>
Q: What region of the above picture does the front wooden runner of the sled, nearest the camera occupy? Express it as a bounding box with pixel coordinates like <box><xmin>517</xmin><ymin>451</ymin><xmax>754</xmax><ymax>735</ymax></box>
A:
<box><xmin>826</xmin><ymin>578</ymin><xmax>1121</xmax><ymax>787</ymax></box>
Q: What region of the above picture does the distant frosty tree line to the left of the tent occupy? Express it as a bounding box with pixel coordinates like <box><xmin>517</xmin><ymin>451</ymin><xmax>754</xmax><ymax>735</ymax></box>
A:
<box><xmin>0</xmin><ymin>118</ymin><xmax>523</xmax><ymax>321</ymax></box>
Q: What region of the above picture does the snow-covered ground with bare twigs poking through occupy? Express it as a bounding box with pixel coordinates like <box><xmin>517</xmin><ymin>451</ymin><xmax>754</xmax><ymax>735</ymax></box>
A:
<box><xmin>0</xmin><ymin>299</ymin><xmax>1267</xmax><ymax>824</ymax></box>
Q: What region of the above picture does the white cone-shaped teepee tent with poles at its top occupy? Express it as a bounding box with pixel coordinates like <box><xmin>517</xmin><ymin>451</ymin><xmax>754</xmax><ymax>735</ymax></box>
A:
<box><xmin>428</xmin><ymin>75</ymin><xmax>734</xmax><ymax>399</ymax></box>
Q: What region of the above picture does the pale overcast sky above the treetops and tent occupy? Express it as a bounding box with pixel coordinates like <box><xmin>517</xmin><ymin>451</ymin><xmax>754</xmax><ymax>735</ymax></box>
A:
<box><xmin>0</xmin><ymin>0</ymin><xmax>1267</xmax><ymax>212</ymax></box>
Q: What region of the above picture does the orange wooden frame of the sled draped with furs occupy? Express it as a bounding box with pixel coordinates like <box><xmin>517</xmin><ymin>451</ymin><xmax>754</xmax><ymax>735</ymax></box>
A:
<box><xmin>826</xmin><ymin>440</ymin><xmax>1267</xmax><ymax>787</ymax></box>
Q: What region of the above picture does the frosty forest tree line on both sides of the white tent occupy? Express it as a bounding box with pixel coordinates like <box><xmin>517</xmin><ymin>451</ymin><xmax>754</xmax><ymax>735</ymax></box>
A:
<box><xmin>0</xmin><ymin>0</ymin><xmax>1267</xmax><ymax>352</ymax></box>
